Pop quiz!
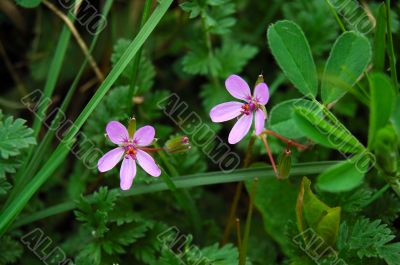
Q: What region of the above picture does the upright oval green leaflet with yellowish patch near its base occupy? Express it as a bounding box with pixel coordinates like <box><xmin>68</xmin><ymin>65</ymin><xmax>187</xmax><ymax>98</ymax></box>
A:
<box><xmin>321</xmin><ymin>32</ymin><xmax>372</xmax><ymax>104</ymax></box>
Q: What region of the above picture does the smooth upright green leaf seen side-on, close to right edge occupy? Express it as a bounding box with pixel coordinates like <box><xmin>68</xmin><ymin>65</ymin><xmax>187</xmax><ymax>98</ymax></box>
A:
<box><xmin>368</xmin><ymin>73</ymin><xmax>396</xmax><ymax>146</ymax></box>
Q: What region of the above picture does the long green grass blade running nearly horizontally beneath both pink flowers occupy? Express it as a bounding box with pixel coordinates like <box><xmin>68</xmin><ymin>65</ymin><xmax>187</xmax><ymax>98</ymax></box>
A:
<box><xmin>13</xmin><ymin>161</ymin><xmax>341</xmax><ymax>228</ymax></box>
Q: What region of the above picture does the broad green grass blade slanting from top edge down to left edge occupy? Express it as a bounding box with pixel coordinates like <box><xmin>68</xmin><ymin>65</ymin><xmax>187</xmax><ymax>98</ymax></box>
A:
<box><xmin>0</xmin><ymin>0</ymin><xmax>173</xmax><ymax>236</ymax></box>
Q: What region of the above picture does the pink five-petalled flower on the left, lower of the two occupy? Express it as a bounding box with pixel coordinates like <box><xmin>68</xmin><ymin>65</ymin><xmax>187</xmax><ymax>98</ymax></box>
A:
<box><xmin>97</xmin><ymin>121</ymin><xmax>161</xmax><ymax>190</ymax></box>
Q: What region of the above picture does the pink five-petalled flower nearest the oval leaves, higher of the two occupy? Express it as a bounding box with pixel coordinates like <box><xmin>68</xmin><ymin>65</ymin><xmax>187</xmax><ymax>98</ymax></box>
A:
<box><xmin>210</xmin><ymin>75</ymin><xmax>269</xmax><ymax>144</ymax></box>
